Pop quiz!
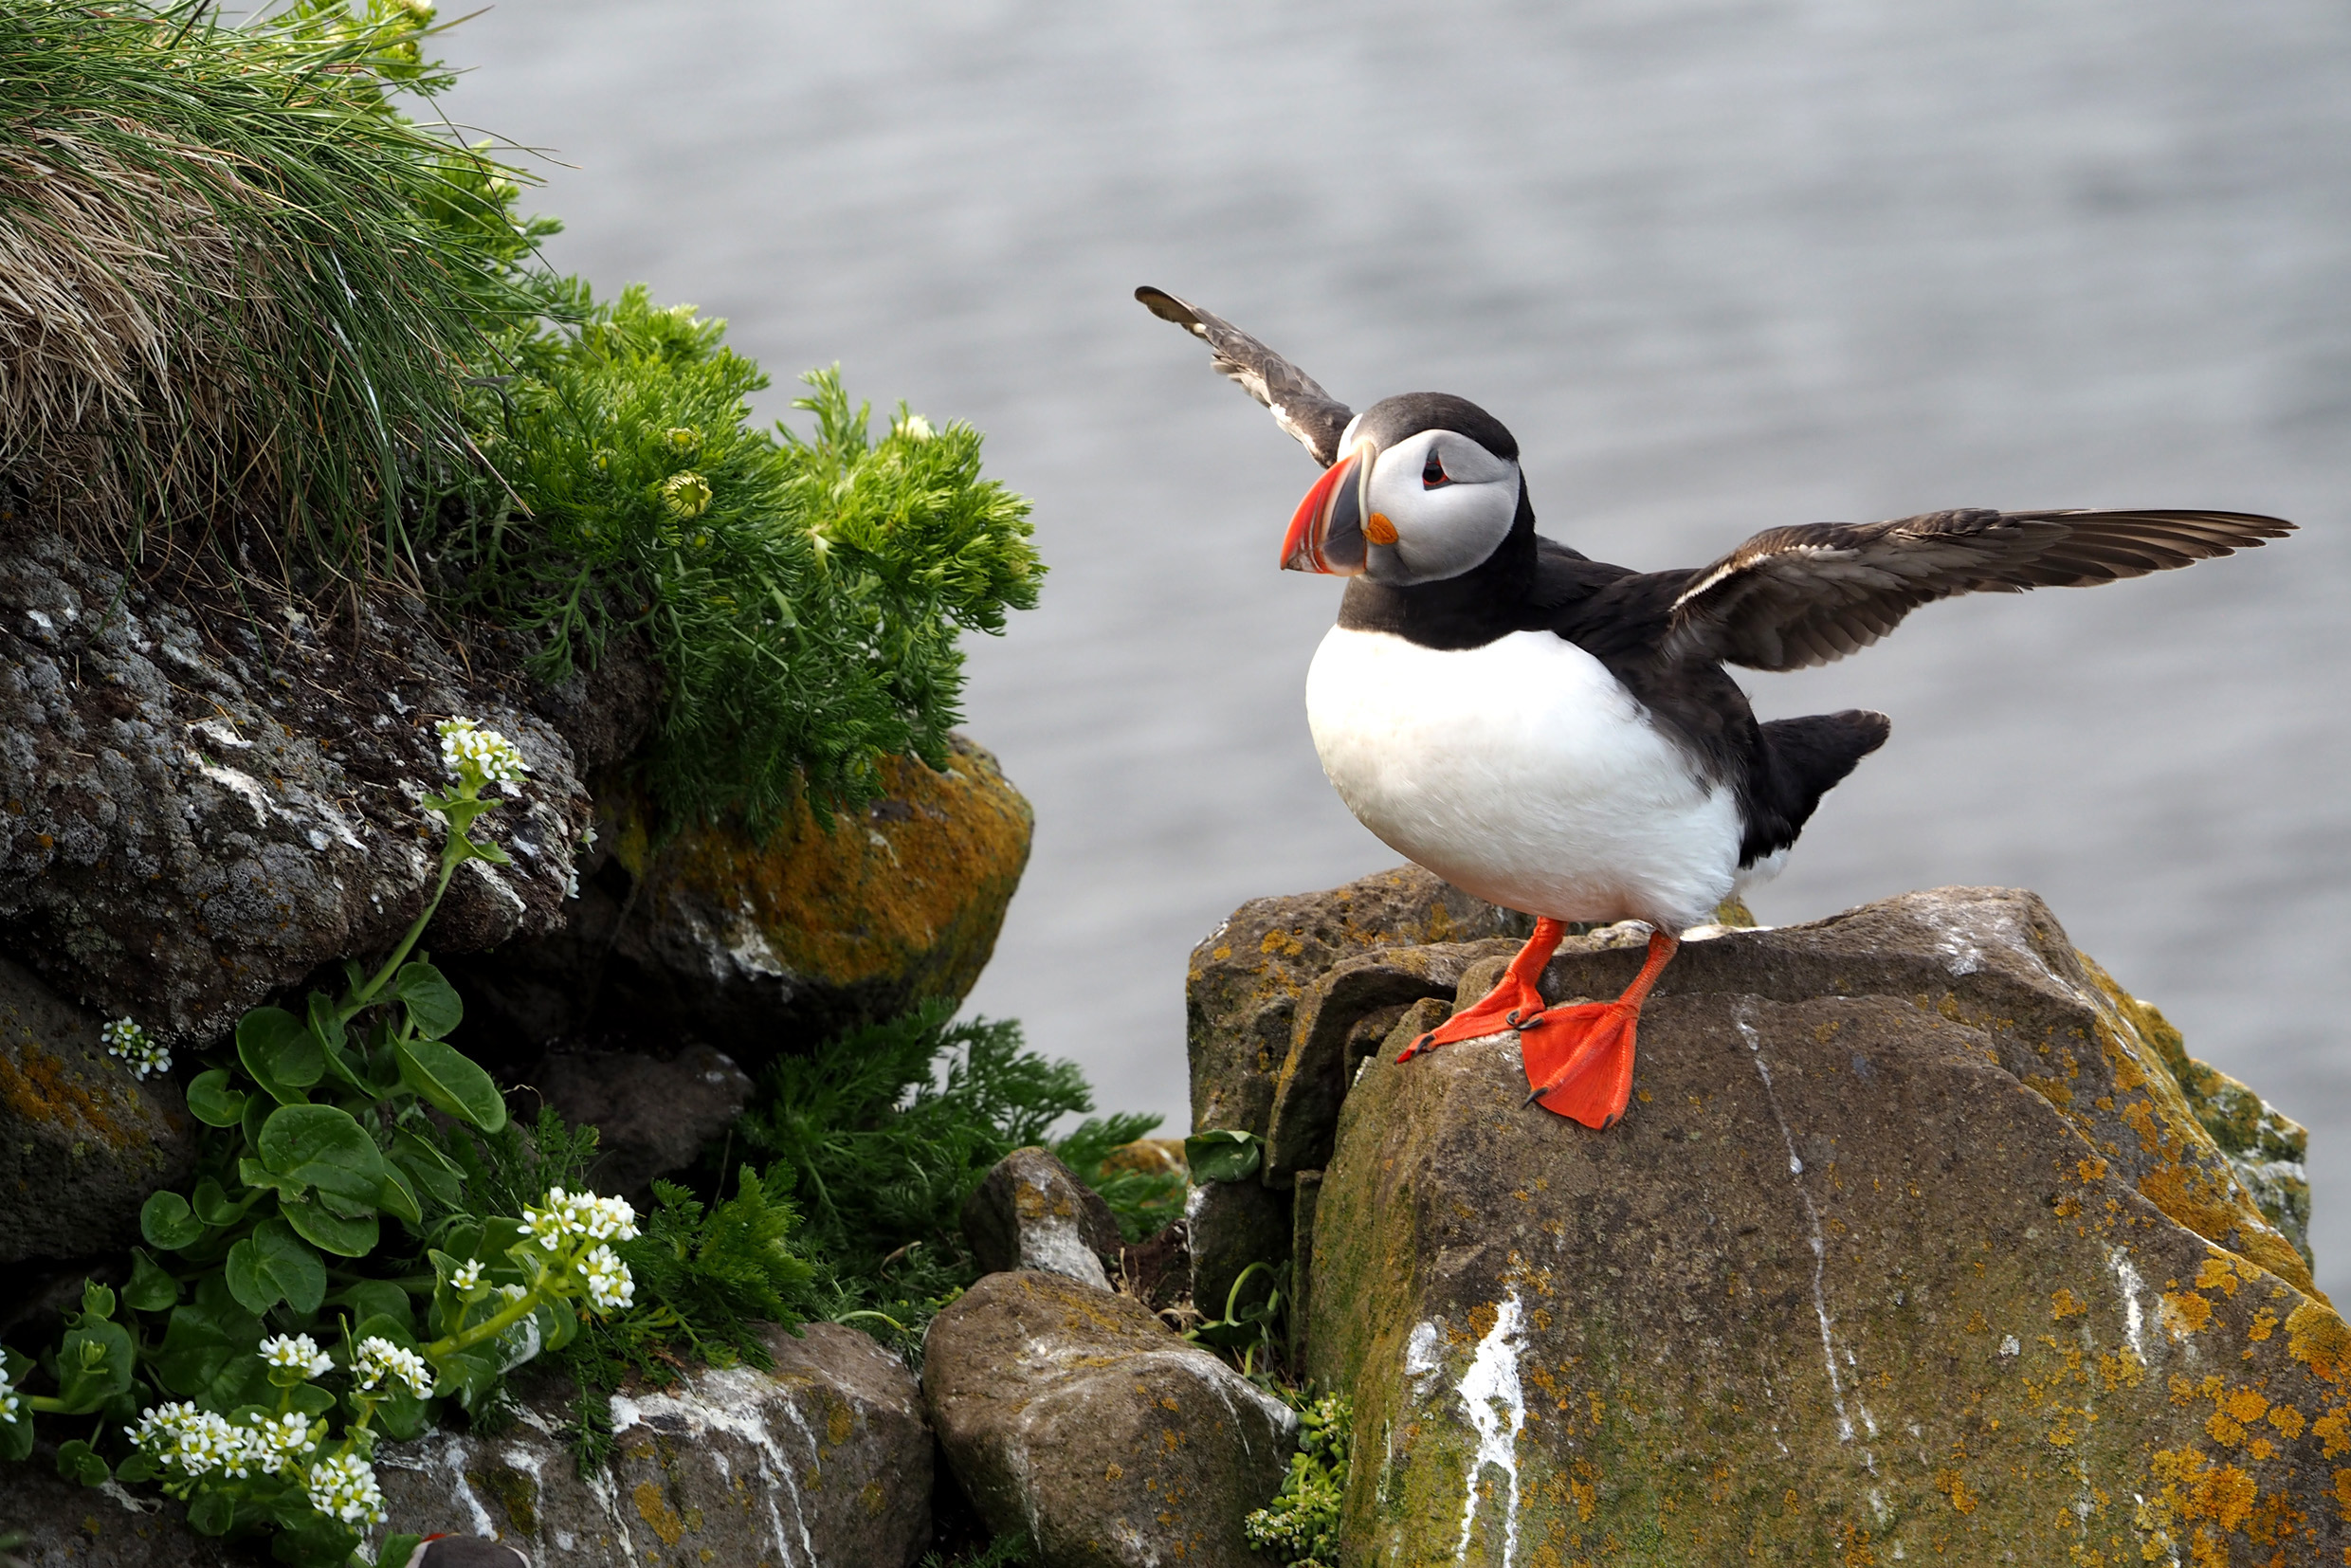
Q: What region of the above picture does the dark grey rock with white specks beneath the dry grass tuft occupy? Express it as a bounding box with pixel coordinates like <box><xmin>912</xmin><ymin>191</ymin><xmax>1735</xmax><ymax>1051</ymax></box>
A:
<box><xmin>0</xmin><ymin>521</ymin><xmax>588</xmax><ymax>1044</ymax></box>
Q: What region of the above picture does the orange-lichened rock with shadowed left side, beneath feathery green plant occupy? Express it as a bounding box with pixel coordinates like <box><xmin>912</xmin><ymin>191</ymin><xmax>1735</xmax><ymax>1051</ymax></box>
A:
<box><xmin>454</xmin><ymin>736</ymin><xmax>1032</xmax><ymax>1067</ymax></box>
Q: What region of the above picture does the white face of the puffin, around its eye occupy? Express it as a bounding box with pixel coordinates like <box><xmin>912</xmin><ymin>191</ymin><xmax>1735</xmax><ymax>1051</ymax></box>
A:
<box><xmin>1363</xmin><ymin>430</ymin><xmax>1519</xmax><ymax>588</ymax></box>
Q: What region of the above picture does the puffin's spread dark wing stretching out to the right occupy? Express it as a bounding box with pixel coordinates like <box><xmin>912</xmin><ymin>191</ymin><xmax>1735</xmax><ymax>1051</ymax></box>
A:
<box><xmin>1667</xmin><ymin>510</ymin><xmax>2294</xmax><ymax>670</ymax></box>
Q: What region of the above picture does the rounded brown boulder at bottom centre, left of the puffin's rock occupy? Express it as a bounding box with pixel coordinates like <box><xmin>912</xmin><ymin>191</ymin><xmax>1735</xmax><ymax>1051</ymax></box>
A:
<box><xmin>921</xmin><ymin>1269</ymin><xmax>1298</xmax><ymax>1568</ymax></box>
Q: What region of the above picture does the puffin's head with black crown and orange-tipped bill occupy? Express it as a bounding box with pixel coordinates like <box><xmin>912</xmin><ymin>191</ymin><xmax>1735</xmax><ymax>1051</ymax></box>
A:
<box><xmin>1282</xmin><ymin>392</ymin><xmax>1522</xmax><ymax>588</ymax></box>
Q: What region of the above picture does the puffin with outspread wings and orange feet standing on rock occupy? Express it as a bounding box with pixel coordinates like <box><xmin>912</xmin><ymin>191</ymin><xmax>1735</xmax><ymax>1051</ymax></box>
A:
<box><xmin>1136</xmin><ymin>287</ymin><xmax>2294</xmax><ymax>1131</ymax></box>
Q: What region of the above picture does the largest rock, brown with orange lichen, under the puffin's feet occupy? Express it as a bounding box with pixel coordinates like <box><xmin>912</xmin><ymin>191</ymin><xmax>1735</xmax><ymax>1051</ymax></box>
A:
<box><xmin>1304</xmin><ymin>888</ymin><xmax>2351</xmax><ymax>1563</ymax></box>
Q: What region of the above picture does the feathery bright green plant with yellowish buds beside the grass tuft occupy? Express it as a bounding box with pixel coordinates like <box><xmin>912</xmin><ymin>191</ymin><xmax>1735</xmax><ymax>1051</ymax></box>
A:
<box><xmin>454</xmin><ymin>283</ymin><xmax>1042</xmax><ymax>825</ymax></box>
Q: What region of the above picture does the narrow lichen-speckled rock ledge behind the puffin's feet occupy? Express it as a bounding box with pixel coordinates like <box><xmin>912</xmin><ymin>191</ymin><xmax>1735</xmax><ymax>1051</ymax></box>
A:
<box><xmin>1185</xmin><ymin>866</ymin><xmax>1535</xmax><ymax>1147</ymax></box>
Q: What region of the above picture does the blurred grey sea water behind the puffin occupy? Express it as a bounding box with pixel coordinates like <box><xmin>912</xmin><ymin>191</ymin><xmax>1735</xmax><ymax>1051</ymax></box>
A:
<box><xmin>447</xmin><ymin>0</ymin><xmax>2351</xmax><ymax>1293</ymax></box>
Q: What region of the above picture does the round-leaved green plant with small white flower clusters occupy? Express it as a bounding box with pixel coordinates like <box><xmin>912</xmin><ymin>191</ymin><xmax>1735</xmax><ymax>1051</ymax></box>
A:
<box><xmin>0</xmin><ymin>720</ymin><xmax>644</xmax><ymax>1566</ymax></box>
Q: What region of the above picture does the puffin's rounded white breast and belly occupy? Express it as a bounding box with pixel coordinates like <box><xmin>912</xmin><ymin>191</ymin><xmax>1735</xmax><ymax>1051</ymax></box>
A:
<box><xmin>1307</xmin><ymin>628</ymin><xmax>1740</xmax><ymax>931</ymax></box>
